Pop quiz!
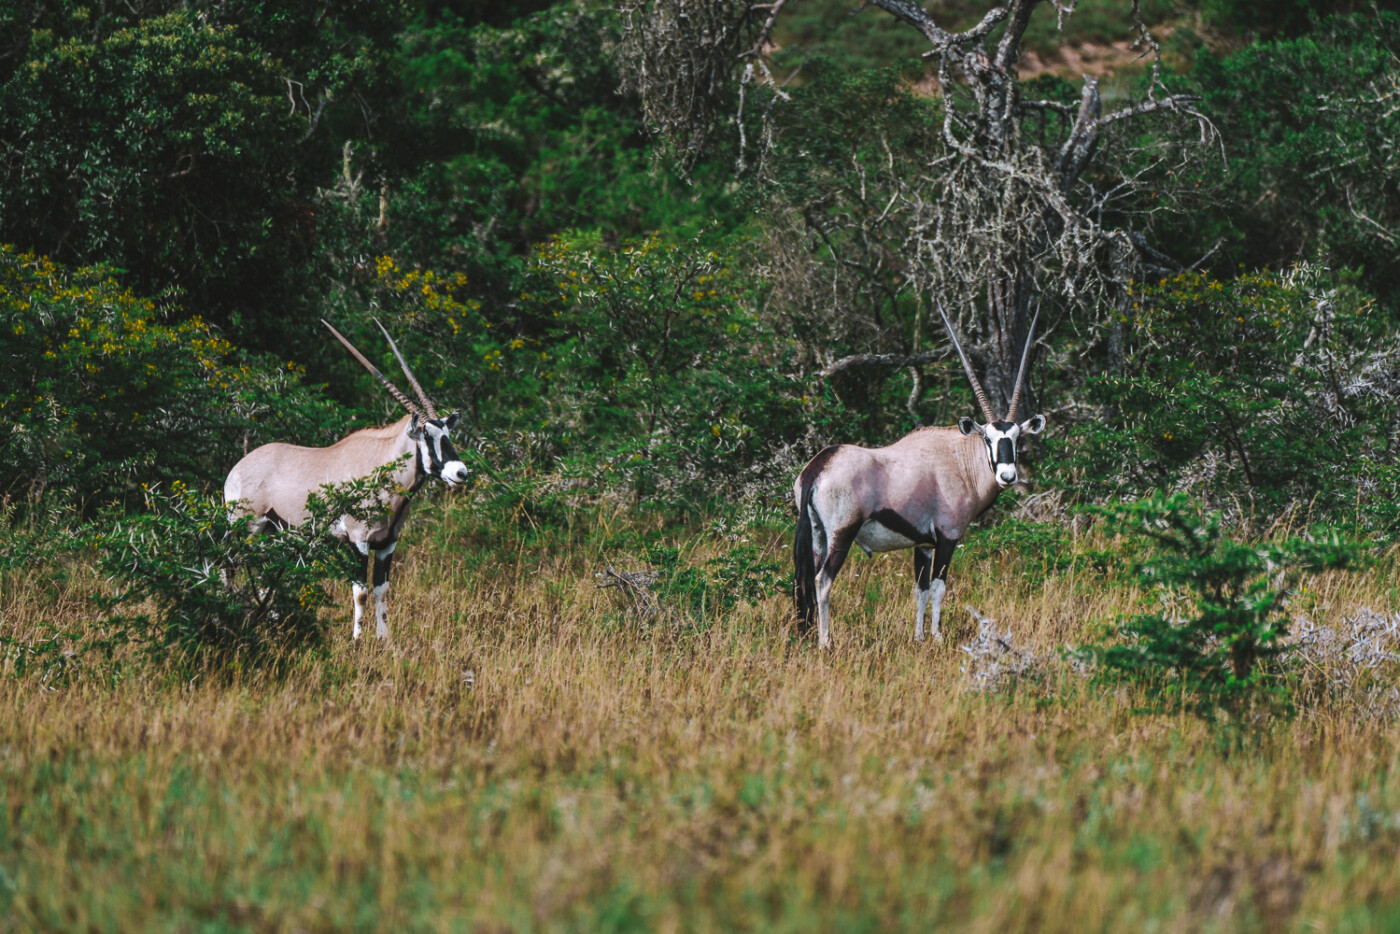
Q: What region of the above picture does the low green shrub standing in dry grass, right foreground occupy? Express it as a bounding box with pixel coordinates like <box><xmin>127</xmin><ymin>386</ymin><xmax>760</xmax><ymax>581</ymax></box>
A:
<box><xmin>1079</xmin><ymin>494</ymin><xmax>1357</xmax><ymax>718</ymax></box>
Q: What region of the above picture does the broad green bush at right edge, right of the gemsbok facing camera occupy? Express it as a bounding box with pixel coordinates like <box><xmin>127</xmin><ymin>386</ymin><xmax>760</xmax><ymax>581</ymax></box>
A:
<box><xmin>1057</xmin><ymin>267</ymin><xmax>1400</xmax><ymax>529</ymax></box>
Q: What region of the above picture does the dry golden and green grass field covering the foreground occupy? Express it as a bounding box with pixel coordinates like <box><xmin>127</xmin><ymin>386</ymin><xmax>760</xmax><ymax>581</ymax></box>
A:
<box><xmin>0</xmin><ymin>497</ymin><xmax>1400</xmax><ymax>933</ymax></box>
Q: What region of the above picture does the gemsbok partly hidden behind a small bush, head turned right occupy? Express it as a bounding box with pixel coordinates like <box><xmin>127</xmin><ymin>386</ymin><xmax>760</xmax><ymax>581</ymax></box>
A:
<box><xmin>224</xmin><ymin>319</ymin><xmax>468</xmax><ymax>639</ymax></box>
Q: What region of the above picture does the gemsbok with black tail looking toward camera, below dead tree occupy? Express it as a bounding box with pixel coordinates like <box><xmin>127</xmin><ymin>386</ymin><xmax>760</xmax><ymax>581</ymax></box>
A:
<box><xmin>792</xmin><ymin>308</ymin><xmax>1046</xmax><ymax>648</ymax></box>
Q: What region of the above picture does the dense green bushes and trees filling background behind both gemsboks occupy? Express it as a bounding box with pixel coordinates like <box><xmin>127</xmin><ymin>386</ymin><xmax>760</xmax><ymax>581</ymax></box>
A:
<box><xmin>0</xmin><ymin>0</ymin><xmax>1400</xmax><ymax>683</ymax></box>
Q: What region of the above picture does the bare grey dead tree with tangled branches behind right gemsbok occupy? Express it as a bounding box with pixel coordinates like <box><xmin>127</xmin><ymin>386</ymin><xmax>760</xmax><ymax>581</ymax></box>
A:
<box><xmin>622</xmin><ymin>0</ymin><xmax>1217</xmax><ymax>417</ymax></box>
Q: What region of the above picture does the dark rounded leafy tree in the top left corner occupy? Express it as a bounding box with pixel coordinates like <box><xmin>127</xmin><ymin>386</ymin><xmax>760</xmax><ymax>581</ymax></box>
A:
<box><xmin>0</xmin><ymin>10</ymin><xmax>302</xmax><ymax>340</ymax></box>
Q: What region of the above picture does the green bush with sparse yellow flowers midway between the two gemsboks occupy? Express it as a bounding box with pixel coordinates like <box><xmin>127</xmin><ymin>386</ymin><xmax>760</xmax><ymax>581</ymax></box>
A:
<box><xmin>511</xmin><ymin>232</ymin><xmax>806</xmax><ymax>500</ymax></box>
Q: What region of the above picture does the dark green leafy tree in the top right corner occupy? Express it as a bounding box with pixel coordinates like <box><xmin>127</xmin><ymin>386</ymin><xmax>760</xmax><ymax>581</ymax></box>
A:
<box><xmin>1158</xmin><ymin>13</ymin><xmax>1400</xmax><ymax>300</ymax></box>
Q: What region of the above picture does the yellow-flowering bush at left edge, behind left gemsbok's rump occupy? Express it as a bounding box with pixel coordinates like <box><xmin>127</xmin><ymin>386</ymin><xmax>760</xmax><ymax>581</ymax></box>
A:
<box><xmin>0</xmin><ymin>248</ymin><xmax>340</xmax><ymax>504</ymax></box>
